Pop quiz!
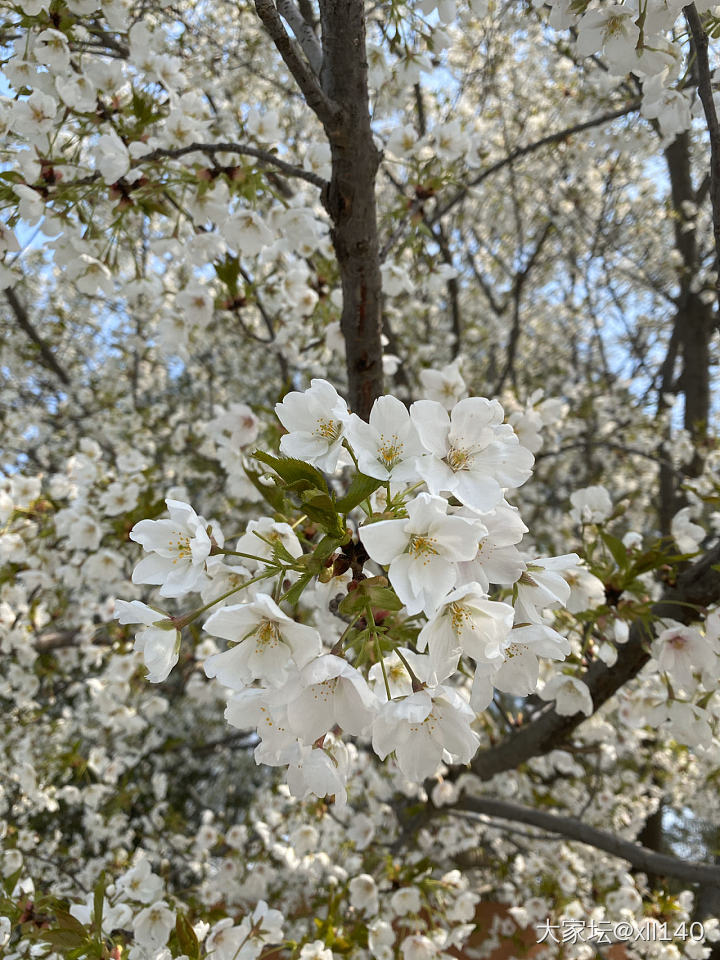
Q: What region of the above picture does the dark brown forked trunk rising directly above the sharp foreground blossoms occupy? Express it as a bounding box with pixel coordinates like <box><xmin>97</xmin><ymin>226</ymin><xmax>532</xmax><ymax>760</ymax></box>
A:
<box><xmin>255</xmin><ymin>0</ymin><xmax>383</xmax><ymax>418</ymax></box>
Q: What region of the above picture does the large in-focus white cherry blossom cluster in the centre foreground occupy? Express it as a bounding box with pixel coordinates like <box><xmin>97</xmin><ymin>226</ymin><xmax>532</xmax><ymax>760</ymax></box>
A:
<box><xmin>121</xmin><ymin>380</ymin><xmax>592</xmax><ymax>803</ymax></box>
